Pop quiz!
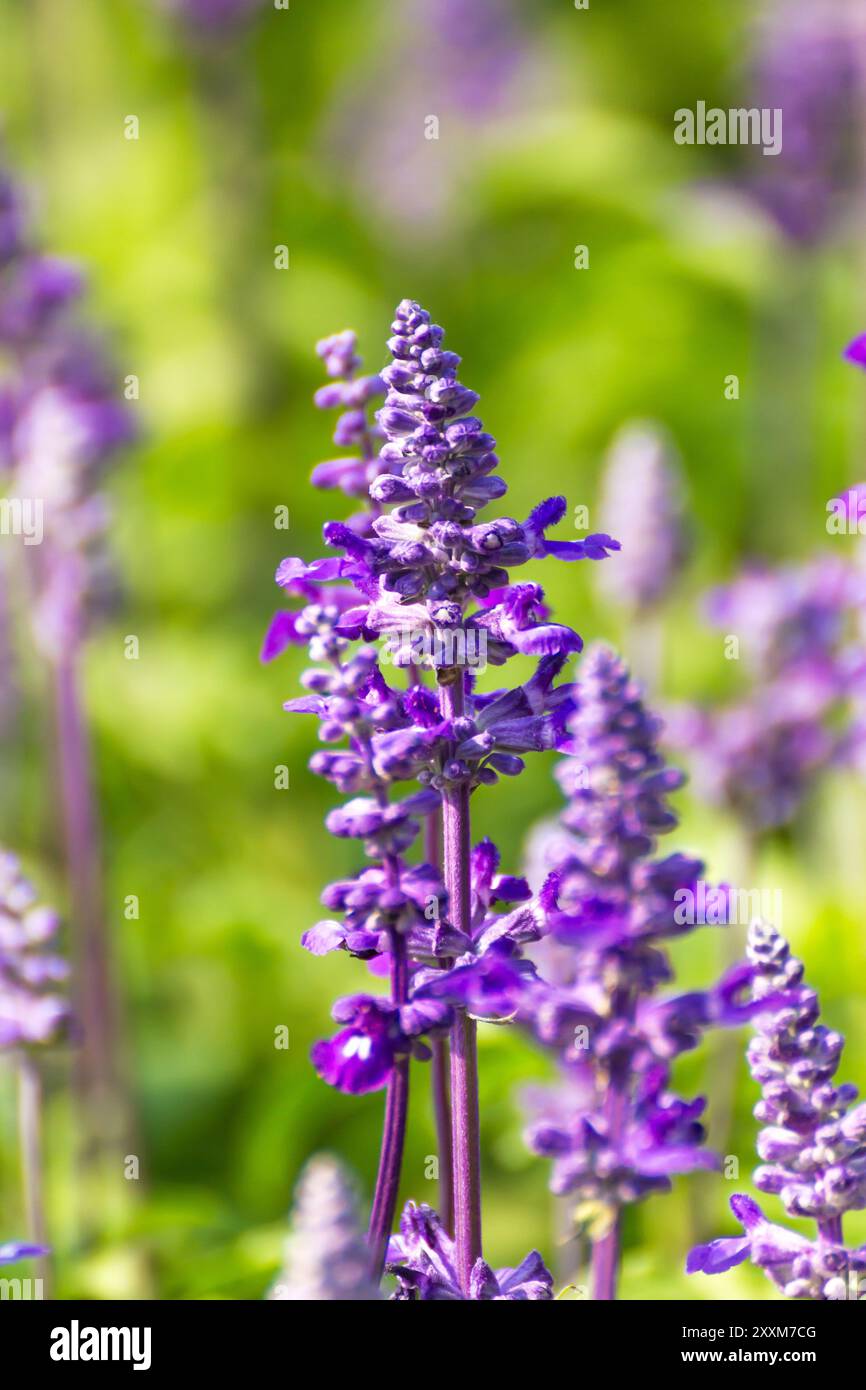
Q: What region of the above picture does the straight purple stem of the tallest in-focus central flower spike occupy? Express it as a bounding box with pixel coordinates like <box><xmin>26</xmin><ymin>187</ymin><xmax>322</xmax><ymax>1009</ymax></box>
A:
<box><xmin>439</xmin><ymin>669</ymin><xmax>481</xmax><ymax>1294</ymax></box>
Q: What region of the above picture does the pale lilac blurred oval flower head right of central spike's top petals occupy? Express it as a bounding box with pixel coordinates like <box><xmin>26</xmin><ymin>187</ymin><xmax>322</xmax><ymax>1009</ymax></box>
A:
<box><xmin>599</xmin><ymin>421</ymin><xmax>687</xmax><ymax>613</ymax></box>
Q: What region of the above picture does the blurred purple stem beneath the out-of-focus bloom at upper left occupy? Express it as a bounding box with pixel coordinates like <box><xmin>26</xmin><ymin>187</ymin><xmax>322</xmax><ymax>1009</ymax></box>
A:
<box><xmin>53</xmin><ymin>651</ymin><xmax>118</xmax><ymax>1109</ymax></box>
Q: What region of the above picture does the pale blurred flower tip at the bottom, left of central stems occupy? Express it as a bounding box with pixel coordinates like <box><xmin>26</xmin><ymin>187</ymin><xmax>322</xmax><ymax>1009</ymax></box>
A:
<box><xmin>267</xmin><ymin>1154</ymin><xmax>379</xmax><ymax>1302</ymax></box>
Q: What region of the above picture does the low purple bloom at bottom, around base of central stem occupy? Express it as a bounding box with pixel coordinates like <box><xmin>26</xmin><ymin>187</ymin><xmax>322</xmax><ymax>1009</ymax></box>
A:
<box><xmin>385</xmin><ymin>1202</ymin><xmax>553</xmax><ymax>1302</ymax></box>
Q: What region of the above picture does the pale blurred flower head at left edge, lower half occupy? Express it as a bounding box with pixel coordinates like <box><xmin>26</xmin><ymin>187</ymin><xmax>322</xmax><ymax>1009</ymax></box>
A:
<box><xmin>0</xmin><ymin>851</ymin><xmax>70</xmax><ymax>1048</ymax></box>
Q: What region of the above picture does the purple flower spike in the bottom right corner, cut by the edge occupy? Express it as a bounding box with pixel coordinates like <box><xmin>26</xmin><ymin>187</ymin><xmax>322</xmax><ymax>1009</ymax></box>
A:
<box><xmin>687</xmin><ymin>922</ymin><xmax>866</xmax><ymax>1300</ymax></box>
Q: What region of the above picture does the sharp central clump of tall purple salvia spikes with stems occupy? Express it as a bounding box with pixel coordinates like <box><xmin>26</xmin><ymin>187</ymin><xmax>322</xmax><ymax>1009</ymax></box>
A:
<box><xmin>277</xmin><ymin>300</ymin><xmax>617</xmax><ymax>1293</ymax></box>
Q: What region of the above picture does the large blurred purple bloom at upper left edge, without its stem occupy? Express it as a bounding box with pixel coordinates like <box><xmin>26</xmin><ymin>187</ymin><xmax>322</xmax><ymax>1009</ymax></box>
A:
<box><xmin>0</xmin><ymin>154</ymin><xmax>133</xmax><ymax>660</ymax></box>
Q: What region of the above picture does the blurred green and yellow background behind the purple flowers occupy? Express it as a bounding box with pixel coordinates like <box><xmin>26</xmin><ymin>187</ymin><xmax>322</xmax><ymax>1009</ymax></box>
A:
<box><xmin>0</xmin><ymin>0</ymin><xmax>866</xmax><ymax>1298</ymax></box>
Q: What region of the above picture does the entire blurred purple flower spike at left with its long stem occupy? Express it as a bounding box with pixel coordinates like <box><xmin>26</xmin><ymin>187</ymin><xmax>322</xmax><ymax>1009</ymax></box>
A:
<box><xmin>0</xmin><ymin>152</ymin><xmax>133</xmax><ymax>1120</ymax></box>
